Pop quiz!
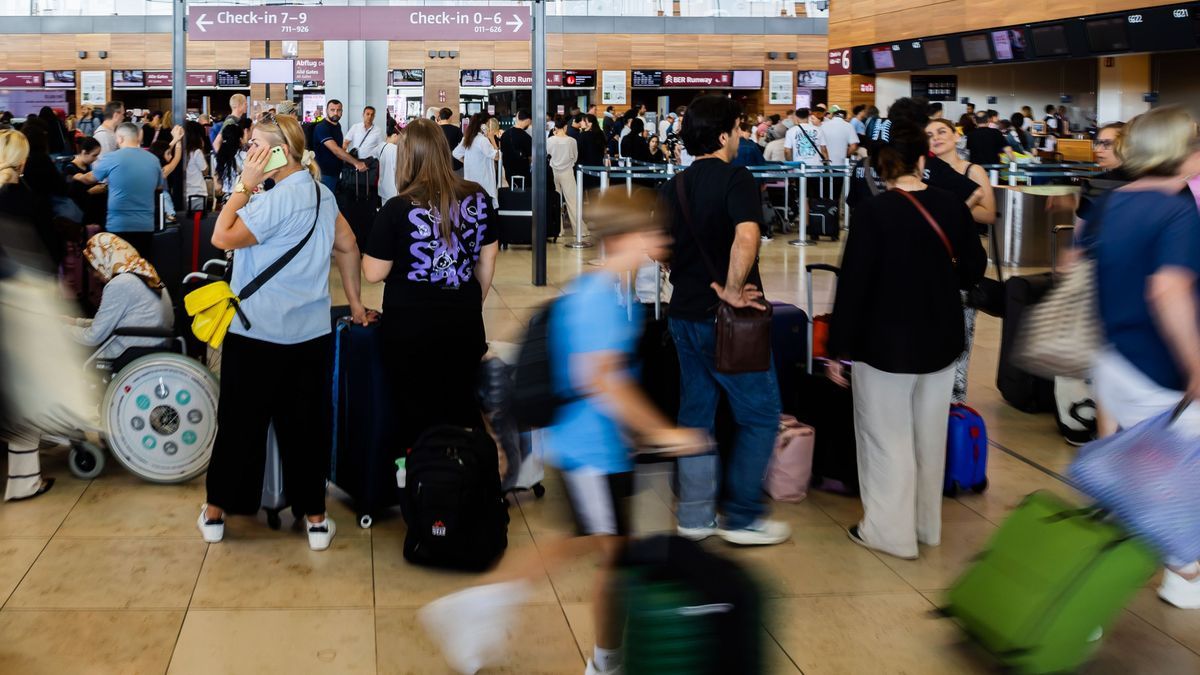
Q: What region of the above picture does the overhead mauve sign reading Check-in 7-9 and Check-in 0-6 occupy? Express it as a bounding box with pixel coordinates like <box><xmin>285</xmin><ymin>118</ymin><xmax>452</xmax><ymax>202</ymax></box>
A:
<box><xmin>187</xmin><ymin>5</ymin><xmax>529</xmax><ymax>41</ymax></box>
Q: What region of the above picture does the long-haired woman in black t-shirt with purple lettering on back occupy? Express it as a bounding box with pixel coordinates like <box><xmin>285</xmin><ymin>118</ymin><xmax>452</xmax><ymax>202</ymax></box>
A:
<box><xmin>362</xmin><ymin>119</ymin><xmax>498</xmax><ymax>449</ymax></box>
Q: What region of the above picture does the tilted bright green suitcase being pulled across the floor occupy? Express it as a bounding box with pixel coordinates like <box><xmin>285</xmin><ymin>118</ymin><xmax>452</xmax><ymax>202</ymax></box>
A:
<box><xmin>943</xmin><ymin>491</ymin><xmax>1158</xmax><ymax>674</ymax></box>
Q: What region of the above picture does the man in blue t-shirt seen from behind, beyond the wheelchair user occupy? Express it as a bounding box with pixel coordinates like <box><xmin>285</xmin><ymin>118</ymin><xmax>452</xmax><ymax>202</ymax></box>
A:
<box><xmin>76</xmin><ymin>123</ymin><xmax>163</xmax><ymax>256</ymax></box>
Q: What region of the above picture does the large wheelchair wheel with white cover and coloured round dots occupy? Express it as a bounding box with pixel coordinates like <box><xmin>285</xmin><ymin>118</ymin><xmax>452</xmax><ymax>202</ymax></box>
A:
<box><xmin>101</xmin><ymin>353</ymin><xmax>217</xmax><ymax>483</ymax></box>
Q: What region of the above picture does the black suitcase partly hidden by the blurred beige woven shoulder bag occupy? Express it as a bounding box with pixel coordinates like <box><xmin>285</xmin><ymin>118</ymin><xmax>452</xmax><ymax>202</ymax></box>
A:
<box><xmin>996</xmin><ymin>273</ymin><xmax>1057</xmax><ymax>413</ymax></box>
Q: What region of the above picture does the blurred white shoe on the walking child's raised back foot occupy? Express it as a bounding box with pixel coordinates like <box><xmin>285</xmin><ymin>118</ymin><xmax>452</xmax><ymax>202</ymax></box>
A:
<box><xmin>416</xmin><ymin>581</ymin><xmax>529</xmax><ymax>675</ymax></box>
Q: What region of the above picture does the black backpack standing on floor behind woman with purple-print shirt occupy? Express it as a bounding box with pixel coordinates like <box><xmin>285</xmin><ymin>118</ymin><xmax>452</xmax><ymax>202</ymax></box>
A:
<box><xmin>403</xmin><ymin>425</ymin><xmax>509</xmax><ymax>572</ymax></box>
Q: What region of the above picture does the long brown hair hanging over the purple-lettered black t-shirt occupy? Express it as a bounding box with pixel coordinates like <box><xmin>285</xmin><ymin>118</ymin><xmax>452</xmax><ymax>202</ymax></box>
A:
<box><xmin>396</xmin><ymin>119</ymin><xmax>484</xmax><ymax>244</ymax></box>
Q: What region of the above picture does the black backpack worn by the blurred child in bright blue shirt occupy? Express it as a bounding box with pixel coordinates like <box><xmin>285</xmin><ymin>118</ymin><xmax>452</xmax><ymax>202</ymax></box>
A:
<box><xmin>510</xmin><ymin>300</ymin><xmax>570</xmax><ymax>429</ymax></box>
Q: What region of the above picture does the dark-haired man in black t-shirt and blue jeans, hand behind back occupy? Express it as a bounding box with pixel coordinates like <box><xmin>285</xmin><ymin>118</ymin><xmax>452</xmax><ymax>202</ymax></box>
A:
<box><xmin>660</xmin><ymin>95</ymin><xmax>791</xmax><ymax>545</ymax></box>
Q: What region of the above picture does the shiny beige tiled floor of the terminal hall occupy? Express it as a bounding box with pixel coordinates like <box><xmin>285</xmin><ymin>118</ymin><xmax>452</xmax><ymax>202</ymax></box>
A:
<box><xmin>0</xmin><ymin>238</ymin><xmax>1200</xmax><ymax>675</ymax></box>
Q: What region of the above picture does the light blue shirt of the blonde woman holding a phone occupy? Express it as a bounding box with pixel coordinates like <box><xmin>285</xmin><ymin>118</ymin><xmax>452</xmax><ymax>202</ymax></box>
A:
<box><xmin>229</xmin><ymin>171</ymin><xmax>337</xmax><ymax>345</ymax></box>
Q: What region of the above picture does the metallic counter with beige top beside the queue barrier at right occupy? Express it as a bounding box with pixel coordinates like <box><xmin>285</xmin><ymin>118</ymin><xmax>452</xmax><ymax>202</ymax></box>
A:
<box><xmin>996</xmin><ymin>185</ymin><xmax>1080</xmax><ymax>267</ymax></box>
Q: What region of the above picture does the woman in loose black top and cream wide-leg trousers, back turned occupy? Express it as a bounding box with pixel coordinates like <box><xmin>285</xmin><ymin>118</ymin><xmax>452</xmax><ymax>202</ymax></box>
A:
<box><xmin>827</xmin><ymin>124</ymin><xmax>988</xmax><ymax>558</ymax></box>
